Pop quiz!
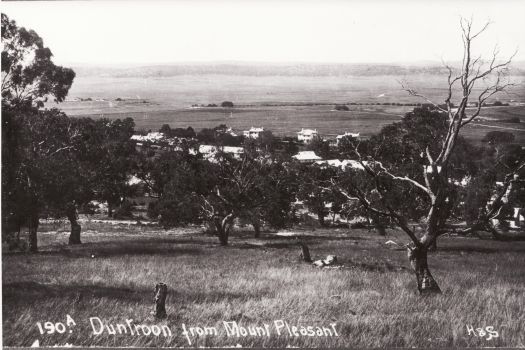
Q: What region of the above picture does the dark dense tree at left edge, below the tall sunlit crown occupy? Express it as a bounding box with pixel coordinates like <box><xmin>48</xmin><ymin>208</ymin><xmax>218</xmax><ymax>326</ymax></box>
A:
<box><xmin>2</xmin><ymin>107</ymin><xmax>80</xmax><ymax>252</ymax></box>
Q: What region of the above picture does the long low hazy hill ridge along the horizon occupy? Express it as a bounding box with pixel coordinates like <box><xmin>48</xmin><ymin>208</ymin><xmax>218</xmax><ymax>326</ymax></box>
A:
<box><xmin>72</xmin><ymin>62</ymin><xmax>525</xmax><ymax>77</ymax></box>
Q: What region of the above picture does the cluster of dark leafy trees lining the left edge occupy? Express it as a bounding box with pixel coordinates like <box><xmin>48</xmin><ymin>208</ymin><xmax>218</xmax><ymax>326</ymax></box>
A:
<box><xmin>2</xmin><ymin>14</ymin><xmax>135</xmax><ymax>252</ymax></box>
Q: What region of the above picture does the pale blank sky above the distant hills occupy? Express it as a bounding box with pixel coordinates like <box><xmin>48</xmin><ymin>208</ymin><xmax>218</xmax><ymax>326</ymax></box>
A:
<box><xmin>1</xmin><ymin>0</ymin><xmax>525</xmax><ymax>65</ymax></box>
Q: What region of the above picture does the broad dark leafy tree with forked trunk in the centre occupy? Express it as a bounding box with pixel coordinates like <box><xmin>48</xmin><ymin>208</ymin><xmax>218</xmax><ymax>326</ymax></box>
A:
<box><xmin>149</xmin><ymin>151</ymin><xmax>293</xmax><ymax>245</ymax></box>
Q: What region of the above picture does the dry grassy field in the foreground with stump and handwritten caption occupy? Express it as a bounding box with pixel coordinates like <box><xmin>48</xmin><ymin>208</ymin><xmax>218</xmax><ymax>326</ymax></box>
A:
<box><xmin>2</xmin><ymin>223</ymin><xmax>525</xmax><ymax>347</ymax></box>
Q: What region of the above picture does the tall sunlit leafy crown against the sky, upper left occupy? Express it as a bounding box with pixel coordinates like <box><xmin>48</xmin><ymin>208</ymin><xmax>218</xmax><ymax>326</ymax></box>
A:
<box><xmin>2</xmin><ymin>13</ymin><xmax>75</xmax><ymax>107</ymax></box>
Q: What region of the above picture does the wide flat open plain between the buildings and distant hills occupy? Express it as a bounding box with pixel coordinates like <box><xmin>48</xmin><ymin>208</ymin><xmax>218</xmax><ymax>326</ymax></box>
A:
<box><xmin>49</xmin><ymin>74</ymin><xmax>525</xmax><ymax>142</ymax></box>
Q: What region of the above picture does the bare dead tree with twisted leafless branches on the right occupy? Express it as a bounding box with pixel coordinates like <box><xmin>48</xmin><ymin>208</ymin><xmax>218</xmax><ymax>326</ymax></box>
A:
<box><xmin>333</xmin><ymin>19</ymin><xmax>515</xmax><ymax>294</ymax></box>
